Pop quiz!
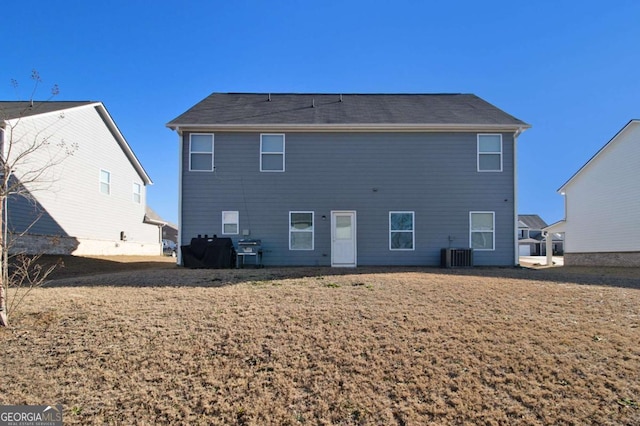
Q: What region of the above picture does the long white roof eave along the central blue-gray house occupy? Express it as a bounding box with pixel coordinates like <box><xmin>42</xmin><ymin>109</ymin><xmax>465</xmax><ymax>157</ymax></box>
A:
<box><xmin>167</xmin><ymin>122</ymin><xmax>531</xmax><ymax>133</ymax></box>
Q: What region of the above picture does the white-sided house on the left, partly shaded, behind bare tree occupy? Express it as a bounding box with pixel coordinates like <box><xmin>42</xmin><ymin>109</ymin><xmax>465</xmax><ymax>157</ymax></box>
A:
<box><xmin>0</xmin><ymin>101</ymin><xmax>165</xmax><ymax>255</ymax></box>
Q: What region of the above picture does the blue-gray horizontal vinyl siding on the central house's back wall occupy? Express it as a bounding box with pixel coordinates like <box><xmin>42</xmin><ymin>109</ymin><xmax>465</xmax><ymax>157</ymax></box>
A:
<box><xmin>181</xmin><ymin>132</ymin><xmax>515</xmax><ymax>265</ymax></box>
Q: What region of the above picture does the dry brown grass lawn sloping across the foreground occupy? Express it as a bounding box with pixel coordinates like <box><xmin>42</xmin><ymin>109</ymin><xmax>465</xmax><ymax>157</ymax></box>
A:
<box><xmin>0</xmin><ymin>259</ymin><xmax>640</xmax><ymax>425</ymax></box>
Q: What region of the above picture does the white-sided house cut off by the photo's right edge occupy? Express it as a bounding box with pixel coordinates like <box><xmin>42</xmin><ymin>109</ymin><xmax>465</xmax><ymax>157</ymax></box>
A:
<box><xmin>545</xmin><ymin>120</ymin><xmax>640</xmax><ymax>266</ymax></box>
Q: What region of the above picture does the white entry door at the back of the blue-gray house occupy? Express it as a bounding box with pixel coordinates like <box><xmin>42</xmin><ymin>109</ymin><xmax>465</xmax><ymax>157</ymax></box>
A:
<box><xmin>331</xmin><ymin>211</ymin><xmax>356</xmax><ymax>267</ymax></box>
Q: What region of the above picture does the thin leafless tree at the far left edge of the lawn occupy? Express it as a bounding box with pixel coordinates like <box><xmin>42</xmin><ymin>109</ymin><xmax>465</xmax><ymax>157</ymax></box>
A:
<box><xmin>0</xmin><ymin>70</ymin><xmax>77</xmax><ymax>326</ymax></box>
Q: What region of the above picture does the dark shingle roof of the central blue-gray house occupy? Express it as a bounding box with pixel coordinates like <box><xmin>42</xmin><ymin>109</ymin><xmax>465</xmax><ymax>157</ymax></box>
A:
<box><xmin>167</xmin><ymin>93</ymin><xmax>529</xmax><ymax>128</ymax></box>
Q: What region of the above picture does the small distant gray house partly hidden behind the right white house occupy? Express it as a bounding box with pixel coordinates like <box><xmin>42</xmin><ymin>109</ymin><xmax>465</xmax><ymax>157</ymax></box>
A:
<box><xmin>518</xmin><ymin>214</ymin><xmax>564</xmax><ymax>256</ymax></box>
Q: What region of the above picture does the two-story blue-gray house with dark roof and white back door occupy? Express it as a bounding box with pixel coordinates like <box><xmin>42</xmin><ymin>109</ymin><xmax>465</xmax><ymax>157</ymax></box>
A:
<box><xmin>167</xmin><ymin>93</ymin><xmax>530</xmax><ymax>266</ymax></box>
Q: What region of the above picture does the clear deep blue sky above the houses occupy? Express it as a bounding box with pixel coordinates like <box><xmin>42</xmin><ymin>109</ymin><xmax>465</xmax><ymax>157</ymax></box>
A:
<box><xmin>0</xmin><ymin>0</ymin><xmax>640</xmax><ymax>223</ymax></box>
